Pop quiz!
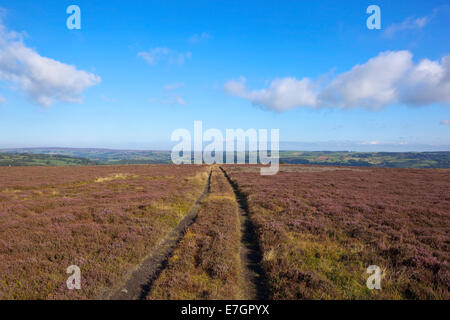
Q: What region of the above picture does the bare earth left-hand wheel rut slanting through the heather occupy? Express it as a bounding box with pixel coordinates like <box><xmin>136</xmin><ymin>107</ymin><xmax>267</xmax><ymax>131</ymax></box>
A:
<box><xmin>109</xmin><ymin>171</ymin><xmax>212</xmax><ymax>300</ymax></box>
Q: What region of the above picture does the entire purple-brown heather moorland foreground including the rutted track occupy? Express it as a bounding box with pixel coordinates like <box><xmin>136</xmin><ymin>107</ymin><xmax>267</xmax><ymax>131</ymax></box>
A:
<box><xmin>0</xmin><ymin>165</ymin><xmax>450</xmax><ymax>299</ymax></box>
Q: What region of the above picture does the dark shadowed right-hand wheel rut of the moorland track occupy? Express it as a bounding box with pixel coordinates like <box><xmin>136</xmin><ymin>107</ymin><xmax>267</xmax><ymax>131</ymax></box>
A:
<box><xmin>220</xmin><ymin>167</ymin><xmax>269</xmax><ymax>300</ymax></box>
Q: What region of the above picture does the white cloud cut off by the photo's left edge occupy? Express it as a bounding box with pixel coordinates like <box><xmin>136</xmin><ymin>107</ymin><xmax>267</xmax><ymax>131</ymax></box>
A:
<box><xmin>0</xmin><ymin>21</ymin><xmax>101</xmax><ymax>107</ymax></box>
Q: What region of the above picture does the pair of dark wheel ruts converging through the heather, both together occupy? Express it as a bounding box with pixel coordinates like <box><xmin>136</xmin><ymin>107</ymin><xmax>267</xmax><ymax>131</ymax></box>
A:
<box><xmin>109</xmin><ymin>167</ymin><xmax>268</xmax><ymax>300</ymax></box>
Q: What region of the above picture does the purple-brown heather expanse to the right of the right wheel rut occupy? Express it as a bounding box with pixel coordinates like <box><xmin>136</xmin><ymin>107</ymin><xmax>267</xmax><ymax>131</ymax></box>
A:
<box><xmin>225</xmin><ymin>165</ymin><xmax>450</xmax><ymax>299</ymax></box>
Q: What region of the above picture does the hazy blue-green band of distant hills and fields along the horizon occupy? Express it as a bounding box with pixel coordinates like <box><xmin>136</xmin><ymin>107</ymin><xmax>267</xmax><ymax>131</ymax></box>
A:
<box><xmin>0</xmin><ymin>148</ymin><xmax>450</xmax><ymax>168</ymax></box>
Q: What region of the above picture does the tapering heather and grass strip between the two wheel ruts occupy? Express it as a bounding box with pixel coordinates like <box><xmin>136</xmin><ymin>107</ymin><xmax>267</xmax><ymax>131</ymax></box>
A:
<box><xmin>147</xmin><ymin>167</ymin><xmax>243</xmax><ymax>299</ymax></box>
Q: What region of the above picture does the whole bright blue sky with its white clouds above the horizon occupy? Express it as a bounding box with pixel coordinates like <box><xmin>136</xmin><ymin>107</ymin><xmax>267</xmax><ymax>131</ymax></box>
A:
<box><xmin>0</xmin><ymin>0</ymin><xmax>450</xmax><ymax>151</ymax></box>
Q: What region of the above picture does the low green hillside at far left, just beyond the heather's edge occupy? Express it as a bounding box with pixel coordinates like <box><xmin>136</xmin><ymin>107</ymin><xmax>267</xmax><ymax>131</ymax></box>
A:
<box><xmin>0</xmin><ymin>153</ymin><xmax>98</xmax><ymax>167</ymax></box>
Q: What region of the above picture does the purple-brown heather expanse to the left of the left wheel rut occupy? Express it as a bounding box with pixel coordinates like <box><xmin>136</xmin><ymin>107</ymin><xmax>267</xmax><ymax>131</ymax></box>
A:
<box><xmin>0</xmin><ymin>165</ymin><xmax>208</xmax><ymax>299</ymax></box>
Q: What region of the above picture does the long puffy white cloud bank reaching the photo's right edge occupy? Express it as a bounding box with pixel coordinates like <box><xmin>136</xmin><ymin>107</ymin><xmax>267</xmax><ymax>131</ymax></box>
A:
<box><xmin>224</xmin><ymin>51</ymin><xmax>450</xmax><ymax>111</ymax></box>
